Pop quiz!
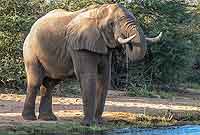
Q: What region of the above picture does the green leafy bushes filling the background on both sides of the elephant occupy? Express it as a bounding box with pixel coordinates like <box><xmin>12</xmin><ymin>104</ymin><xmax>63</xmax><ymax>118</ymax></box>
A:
<box><xmin>0</xmin><ymin>0</ymin><xmax>200</xmax><ymax>95</ymax></box>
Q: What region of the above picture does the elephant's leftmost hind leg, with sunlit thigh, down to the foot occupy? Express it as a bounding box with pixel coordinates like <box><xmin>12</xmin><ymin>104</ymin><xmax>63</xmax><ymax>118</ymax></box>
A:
<box><xmin>22</xmin><ymin>63</ymin><xmax>43</xmax><ymax>120</ymax></box>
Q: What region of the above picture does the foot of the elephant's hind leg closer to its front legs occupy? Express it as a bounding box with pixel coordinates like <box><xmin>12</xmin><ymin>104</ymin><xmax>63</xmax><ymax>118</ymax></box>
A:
<box><xmin>38</xmin><ymin>112</ymin><xmax>57</xmax><ymax>121</ymax></box>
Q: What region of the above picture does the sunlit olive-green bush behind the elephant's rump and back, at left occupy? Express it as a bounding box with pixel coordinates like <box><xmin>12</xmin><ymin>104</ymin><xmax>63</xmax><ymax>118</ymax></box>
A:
<box><xmin>0</xmin><ymin>0</ymin><xmax>93</xmax><ymax>88</ymax></box>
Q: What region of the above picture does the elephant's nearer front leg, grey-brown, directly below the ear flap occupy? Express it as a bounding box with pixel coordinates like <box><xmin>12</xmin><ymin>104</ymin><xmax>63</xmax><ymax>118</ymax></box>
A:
<box><xmin>71</xmin><ymin>51</ymin><xmax>100</xmax><ymax>126</ymax></box>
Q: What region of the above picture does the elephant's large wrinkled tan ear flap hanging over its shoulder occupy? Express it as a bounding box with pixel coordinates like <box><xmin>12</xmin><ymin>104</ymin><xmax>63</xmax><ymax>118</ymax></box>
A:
<box><xmin>66</xmin><ymin>15</ymin><xmax>108</xmax><ymax>54</ymax></box>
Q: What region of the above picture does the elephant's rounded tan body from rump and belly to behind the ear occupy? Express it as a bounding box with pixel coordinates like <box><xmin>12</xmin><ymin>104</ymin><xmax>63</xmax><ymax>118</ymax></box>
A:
<box><xmin>23</xmin><ymin>10</ymin><xmax>73</xmax><ymax>79</ymax></box>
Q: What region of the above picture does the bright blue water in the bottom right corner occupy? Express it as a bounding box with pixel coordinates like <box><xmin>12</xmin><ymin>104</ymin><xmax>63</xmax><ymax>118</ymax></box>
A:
<box><xmin>104</xmin><ymin>125</ymin><xmax>200</xmax><ymax>135</ymax></box>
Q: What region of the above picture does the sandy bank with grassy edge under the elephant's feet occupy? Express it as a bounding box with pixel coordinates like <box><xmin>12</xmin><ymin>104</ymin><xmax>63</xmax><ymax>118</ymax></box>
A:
<box><xmin>0</xmin><ymin>91</ymin><xmax>200</xmax><ymax>134</ymax></box>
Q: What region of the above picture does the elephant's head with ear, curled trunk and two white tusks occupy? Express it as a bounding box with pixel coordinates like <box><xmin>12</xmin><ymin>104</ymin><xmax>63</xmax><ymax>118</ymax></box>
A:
<box><xmin>67</xmin><ymin>4</ymin><xmax>161</xmax><ymax>61</ymax></box>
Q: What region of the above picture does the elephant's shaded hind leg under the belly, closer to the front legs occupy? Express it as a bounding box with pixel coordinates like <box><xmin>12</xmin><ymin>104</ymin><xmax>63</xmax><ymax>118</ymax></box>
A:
<box><xmin>38</xmin><ymin>78</ymin><xmax>60</xmax><ymax>120</ymax></box>
